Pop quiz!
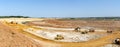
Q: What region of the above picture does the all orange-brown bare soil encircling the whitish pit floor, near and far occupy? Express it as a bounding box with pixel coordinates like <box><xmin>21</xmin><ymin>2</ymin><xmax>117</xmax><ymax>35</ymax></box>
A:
<box><xmin>0</xmin><ymin>19</ymin><xmax>120</xmax><ymax>47</ymax></box>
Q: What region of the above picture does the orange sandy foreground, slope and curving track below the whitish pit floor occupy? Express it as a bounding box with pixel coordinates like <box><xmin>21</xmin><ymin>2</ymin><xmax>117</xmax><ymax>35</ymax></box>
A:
<box><xmin>0</xmin><ymin>19</ymin><xmax>120</xmax><ymax>47</ymax></box>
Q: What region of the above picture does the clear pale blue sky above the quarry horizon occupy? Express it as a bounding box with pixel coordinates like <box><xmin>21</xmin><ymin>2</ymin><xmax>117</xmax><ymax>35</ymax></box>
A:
<box><xmin>0</xmin><ymin>0</ymin><xmax>120</xmax><ymax>17</ymax></box>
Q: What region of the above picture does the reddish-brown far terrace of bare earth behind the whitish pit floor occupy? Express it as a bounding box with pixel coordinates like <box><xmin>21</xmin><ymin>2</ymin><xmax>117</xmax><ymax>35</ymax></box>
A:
<box><xmin>28</xmin><ymin>19</ymin><xmax>120</xmax><ymax>30</ymax></box>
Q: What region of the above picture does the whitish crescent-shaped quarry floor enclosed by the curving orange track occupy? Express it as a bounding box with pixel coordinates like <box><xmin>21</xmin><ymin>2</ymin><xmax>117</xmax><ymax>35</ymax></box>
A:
<box><xmin>24</xmin><ymin>27</ymin><xmax>108</xmax><ymax>42</ymax></box>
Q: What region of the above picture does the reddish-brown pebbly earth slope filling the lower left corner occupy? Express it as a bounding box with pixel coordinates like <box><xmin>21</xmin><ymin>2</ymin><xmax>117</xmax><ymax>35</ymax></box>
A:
<box><xmin>0</xmin><ymin>22</ymin><xmax>41</xmax><ymax>47</ymax></box>
